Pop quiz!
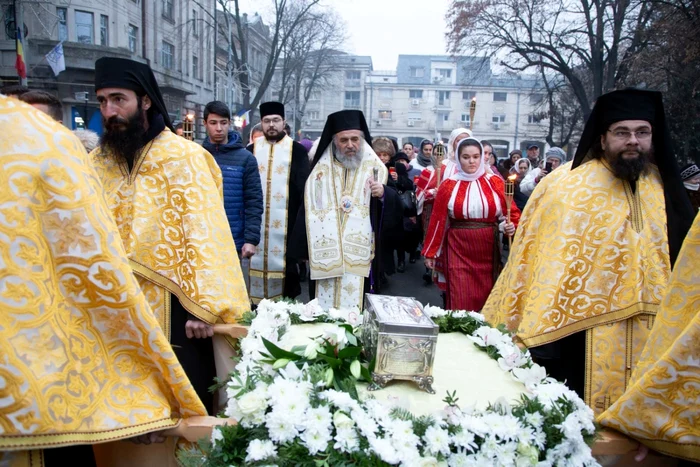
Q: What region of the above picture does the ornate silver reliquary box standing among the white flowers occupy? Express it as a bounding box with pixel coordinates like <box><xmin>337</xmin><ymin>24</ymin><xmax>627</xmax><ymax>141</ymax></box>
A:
<box><xmin>362</xmin><ymin>294</ymin><xmax>439</xmax><ymax>394</ymax></box>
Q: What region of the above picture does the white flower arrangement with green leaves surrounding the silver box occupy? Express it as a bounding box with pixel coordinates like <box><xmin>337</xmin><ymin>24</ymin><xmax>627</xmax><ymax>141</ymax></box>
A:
<box><xmin>190</xmin><ymin>300</ymin><xmax>598</xmax><ymax>467</ymax></box>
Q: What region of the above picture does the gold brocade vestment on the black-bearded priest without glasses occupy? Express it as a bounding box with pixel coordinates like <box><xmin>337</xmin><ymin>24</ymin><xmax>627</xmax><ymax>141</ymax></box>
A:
<box><xmin>92</xmin><ymin>128</ymin><xmax>250</xmax><ymax>336</ymax></box>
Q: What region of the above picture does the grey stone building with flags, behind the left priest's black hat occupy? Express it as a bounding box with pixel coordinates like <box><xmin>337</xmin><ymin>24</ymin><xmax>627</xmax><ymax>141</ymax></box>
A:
<box><xmin>0</xmin><ymin>0</ymin><xmax>215</xmax><ymax>139</ymax></box>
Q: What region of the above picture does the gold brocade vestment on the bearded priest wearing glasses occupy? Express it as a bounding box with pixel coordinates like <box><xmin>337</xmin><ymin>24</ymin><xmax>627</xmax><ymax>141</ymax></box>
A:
<box><xmin>483</xmin><ymin>160</ymin><xmax>671</xmax><ymax>414</ymax></box>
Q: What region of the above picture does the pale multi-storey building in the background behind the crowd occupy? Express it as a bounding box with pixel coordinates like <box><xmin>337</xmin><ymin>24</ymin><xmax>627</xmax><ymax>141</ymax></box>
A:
<box><xmin>302</xmin><ymin>55</ymin><xmax>547</xmax><ymax>157</ymax></box>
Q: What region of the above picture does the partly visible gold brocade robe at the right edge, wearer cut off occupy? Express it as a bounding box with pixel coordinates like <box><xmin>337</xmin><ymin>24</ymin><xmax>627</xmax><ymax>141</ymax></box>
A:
<box><xmin>598</xmin><ymin>216</ymin><xmax>700</xmax><ymax>462</ymax></box>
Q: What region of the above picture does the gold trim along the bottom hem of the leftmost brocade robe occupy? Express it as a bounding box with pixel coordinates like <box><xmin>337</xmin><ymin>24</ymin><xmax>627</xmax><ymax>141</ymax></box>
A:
<box><xmin>0</xmin><ymin>418</ymin><xmax>181</xmax><ymax>451</ymax></box>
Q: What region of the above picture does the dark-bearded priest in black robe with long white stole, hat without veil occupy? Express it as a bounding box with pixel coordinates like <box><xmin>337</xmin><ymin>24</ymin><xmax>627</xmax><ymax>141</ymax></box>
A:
<box><xmin>248</xmin><ymin>102</ymin><xmax>309</xmax><ymax>304</ymax></box>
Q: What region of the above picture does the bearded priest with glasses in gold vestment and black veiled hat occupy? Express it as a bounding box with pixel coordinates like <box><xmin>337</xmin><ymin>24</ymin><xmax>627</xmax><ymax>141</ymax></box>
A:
<box><xmin>483</xmin><ymin>90</ymin><xmax>693</xmax><ymax>414</ymax></box>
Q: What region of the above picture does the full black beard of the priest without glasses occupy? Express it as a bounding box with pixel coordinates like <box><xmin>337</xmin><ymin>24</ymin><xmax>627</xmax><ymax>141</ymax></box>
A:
<box><xmin>100</xmin><ymin>99</ymin><xmax>146</xmax><ymax>167</ymax></box>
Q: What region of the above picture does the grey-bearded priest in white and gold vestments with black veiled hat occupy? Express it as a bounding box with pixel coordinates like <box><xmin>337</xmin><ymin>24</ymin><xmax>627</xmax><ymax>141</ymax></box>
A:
<box><xmin>291</xmin><ymin>110</ymin><xmax>403</xmax><ymax>310</ymax></box>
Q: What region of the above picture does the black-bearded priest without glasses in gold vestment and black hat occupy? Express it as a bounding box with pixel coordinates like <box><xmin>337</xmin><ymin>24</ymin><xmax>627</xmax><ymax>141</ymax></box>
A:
<box><xmin>92</xmin><ymin>58</ymin><xmax>250</xmax><ymax>412</ymax></box>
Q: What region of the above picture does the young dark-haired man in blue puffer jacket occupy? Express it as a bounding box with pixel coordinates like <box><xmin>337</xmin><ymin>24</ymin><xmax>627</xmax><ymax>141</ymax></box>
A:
<box><xmin>202</xmin><ymin>101</ymin><xmax>263</xmax><ymax>258</ymax></box>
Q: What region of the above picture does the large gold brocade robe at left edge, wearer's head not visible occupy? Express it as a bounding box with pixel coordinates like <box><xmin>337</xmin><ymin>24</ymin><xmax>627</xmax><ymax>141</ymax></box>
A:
<box><xmin>0</xmin><ymin>96</ymin><xmax>206</xmax><ymax>465</ymax></box>
